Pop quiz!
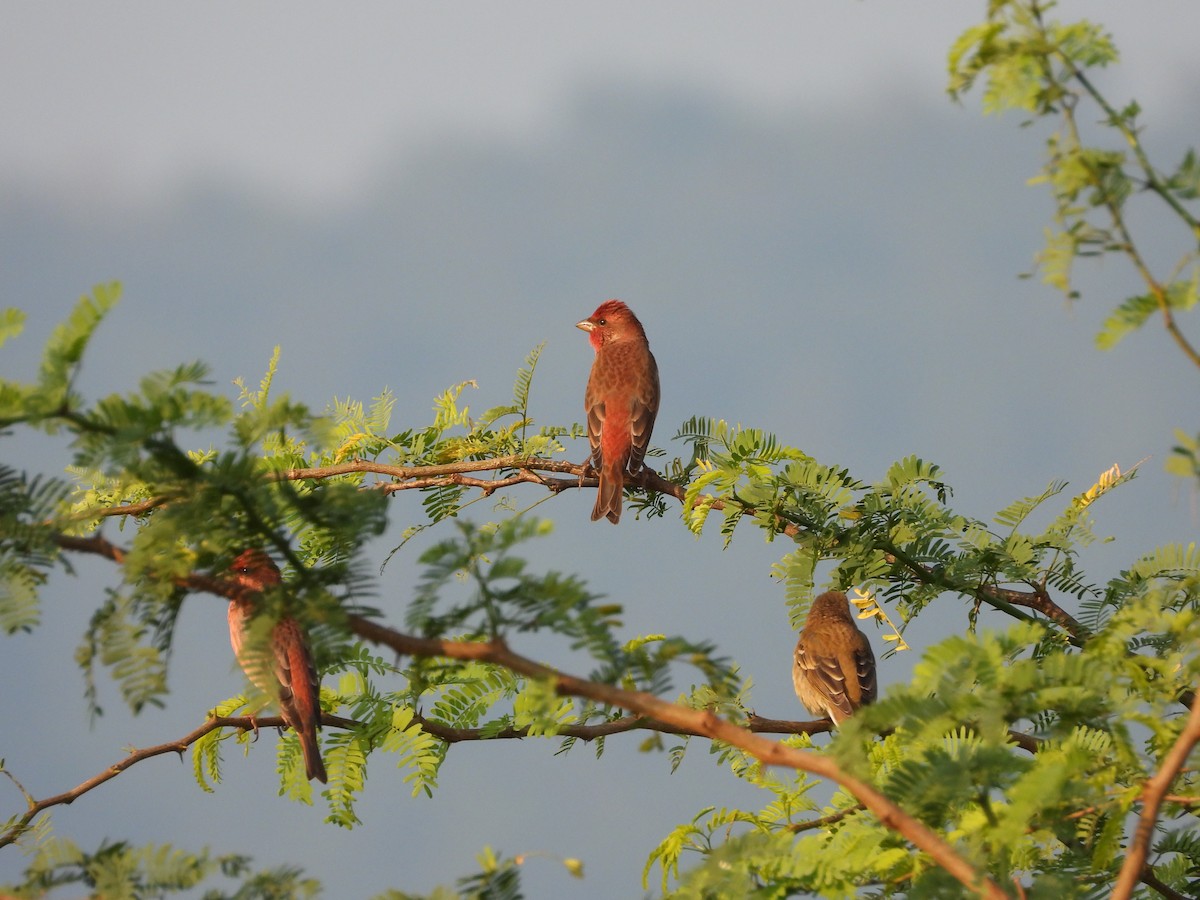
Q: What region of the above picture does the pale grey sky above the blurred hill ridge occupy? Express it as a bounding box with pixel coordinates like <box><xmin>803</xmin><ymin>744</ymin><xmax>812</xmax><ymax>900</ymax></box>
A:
<box><xmin>0</xmin><ymin>0</ymin><xmax>1198</xmax><ymax>200</ymax></box>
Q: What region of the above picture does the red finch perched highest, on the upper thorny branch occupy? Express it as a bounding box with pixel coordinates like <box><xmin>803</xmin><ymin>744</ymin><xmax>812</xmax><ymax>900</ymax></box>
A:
<box><xmin>576</xmin><ymin>300</ymin><xmax>659</xmax><ymax>524</ymax></box>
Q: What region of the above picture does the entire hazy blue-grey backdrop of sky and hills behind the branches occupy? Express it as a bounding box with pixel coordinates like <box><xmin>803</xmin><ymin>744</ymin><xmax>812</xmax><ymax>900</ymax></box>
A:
<box><xmin>0</xmin><ymin>0</ymin><xmax>1200</xmax><ymax>898</ymax></box>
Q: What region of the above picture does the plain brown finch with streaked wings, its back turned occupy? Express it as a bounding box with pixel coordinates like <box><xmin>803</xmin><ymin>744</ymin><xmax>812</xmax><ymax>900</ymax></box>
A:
<box><xmin>792</xmin><ymin>590</ymin><xmax>877</xmax><ymax>725</ymax></box>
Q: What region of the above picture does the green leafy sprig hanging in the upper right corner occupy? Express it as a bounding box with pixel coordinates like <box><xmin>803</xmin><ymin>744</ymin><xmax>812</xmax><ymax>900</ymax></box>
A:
<box><xmin>949</xmin><ymin>0</ymin><xmax>1200</xmax><ymax>501</ymax></box>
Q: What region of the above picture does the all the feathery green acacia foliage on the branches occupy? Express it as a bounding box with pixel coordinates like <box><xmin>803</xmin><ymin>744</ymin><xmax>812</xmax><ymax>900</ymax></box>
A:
<box><xmin>0</xmin><ymin>2</ymin><xmax>1200</xmax><ymax>898</ymax></box>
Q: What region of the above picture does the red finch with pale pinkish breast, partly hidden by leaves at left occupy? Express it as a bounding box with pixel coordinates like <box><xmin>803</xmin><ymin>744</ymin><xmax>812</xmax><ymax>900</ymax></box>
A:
<box><xmin>229</xmin><ymin>550</ymin><xmax>325</xmax><ymax>781</ymax></box>
